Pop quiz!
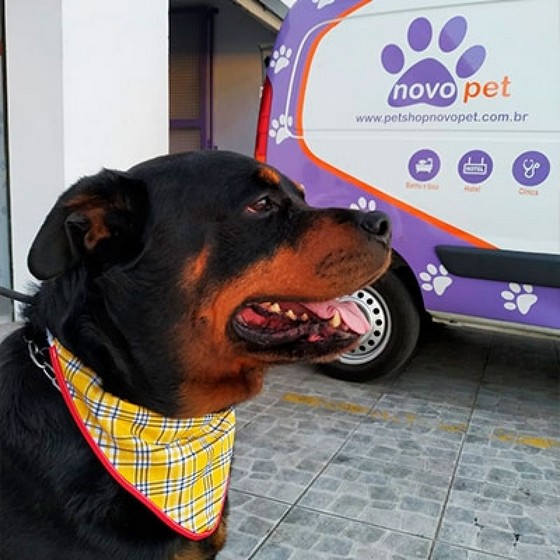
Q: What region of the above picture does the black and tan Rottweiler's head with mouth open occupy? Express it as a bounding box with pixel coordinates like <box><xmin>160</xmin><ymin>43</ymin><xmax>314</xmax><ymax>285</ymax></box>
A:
<box><xmin>29</xmin><ymin>152</ymin><xmax>390</xmax><ymax>415</ymax></box>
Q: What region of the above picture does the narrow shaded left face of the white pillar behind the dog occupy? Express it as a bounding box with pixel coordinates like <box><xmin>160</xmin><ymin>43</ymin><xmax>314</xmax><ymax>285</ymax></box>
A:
<box><xmin>5</xmin><ymin>0</ymin><xmax>64</xmax><ymax>290</ymax></box>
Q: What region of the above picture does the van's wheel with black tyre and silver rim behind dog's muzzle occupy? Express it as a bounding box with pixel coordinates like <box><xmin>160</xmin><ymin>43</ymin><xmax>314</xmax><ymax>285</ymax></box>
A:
<box><xmin>319</xmin><ymin>270</ymin><xmax>420</xmax><ymax>381</ymax></box>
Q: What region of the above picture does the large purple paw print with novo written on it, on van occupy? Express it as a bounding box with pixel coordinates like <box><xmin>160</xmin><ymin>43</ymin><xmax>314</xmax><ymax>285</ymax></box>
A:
<box><xmin>381</xmin><ymin>16</ymin><xmax>486</xmax><ymax>107</ymax></box>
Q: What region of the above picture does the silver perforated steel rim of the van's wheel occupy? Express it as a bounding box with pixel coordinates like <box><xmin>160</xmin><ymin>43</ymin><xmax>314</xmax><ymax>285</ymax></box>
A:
<box><xmin>338</xmin><ymin>286</ymin><xmax>391</xmax><ymax>366</ymax></box>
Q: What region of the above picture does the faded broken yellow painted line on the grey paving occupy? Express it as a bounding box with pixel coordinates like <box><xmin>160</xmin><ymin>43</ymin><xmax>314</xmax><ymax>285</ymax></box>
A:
<box><xmin>282</xmin><ymin>393</ymin><xmax>560</xmax><ymax>449</ymax></box>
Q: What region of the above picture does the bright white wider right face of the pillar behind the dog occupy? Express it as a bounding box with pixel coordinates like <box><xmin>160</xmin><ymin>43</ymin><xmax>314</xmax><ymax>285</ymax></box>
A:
<box><xmin>61</xmin><ymin>0</ymin><xmax>169</xmax><ymax>181</ymax></box>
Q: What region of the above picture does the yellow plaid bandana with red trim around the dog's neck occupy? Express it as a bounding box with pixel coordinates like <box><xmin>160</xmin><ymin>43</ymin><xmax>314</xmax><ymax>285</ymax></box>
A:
<box><xmin>49</xmin><ymin>335</ymin><xmax>235</xmax><ymax>540</ymax></box>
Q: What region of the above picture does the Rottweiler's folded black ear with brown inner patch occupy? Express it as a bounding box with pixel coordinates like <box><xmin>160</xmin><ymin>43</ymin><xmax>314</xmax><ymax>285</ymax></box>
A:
<box><xmin>27</xmin><ymin>170</ymin><xmax>149</xmax><ymax>280</ymax></box>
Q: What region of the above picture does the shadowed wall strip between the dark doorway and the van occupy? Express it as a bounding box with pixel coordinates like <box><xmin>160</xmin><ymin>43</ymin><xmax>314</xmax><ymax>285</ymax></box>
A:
<box><xmin>214</xmin><ymin>2</ymin><xmax>276</xmax><ymax>156</ymax></box>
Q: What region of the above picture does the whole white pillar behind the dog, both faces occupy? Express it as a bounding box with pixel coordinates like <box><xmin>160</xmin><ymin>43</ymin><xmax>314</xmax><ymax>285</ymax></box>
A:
<box><xmin>5</xmin><ymin>0</ymin><xmax>168</xmax><ymax>296</ymax></box>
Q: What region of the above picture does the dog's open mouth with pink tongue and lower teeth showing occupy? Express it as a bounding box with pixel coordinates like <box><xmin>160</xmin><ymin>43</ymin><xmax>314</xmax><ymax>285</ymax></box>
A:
<box><xmin>232</xmin><ymin>300</ymin><xmax>370</xmax><ymax>359</ymax></box>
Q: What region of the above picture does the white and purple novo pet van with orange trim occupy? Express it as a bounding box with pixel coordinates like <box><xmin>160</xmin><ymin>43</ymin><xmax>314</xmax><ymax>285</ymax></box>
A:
<box><xmin>255</xmin><ymin>0</ymin><xmax>560</xmax><ymax>380</ymax></box>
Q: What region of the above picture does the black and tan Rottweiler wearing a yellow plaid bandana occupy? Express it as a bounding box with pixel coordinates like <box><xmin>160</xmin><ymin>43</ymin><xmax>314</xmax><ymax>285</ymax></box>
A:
<box><xmin>0</xmin><ymin>151</ymin><xmax>390</xmax><ymax>560</ymax></box>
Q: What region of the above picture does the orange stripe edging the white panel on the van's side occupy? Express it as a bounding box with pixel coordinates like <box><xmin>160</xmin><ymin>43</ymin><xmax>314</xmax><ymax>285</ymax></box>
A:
<box><xmin>296</xmin><ymin>0</ymin><xmax>498</xmax><ymax>249</ymax></box>
